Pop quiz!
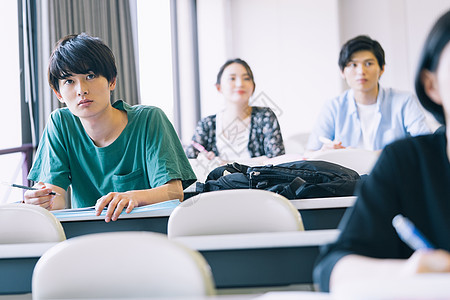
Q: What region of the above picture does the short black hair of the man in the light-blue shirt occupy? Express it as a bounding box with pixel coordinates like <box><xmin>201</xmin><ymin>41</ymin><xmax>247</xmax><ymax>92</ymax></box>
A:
<box><xmin>338</xmin><ymin>35</ymin><xmax>386</xmax><ymax>71</ymax></box>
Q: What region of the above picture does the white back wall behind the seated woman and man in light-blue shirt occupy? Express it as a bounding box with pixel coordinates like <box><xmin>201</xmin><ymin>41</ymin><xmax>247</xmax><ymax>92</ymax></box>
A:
<box><xmin>197</xmin><ymin>0</ymin><xmax>450</xmax><ymax>151</ymax></box>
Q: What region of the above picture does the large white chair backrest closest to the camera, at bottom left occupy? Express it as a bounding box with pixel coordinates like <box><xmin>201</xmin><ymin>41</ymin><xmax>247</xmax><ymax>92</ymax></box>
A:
<box><xmin>32</xmin><ymin>231</ymin><xmax>214</xmax><ymax>300</ymax></box>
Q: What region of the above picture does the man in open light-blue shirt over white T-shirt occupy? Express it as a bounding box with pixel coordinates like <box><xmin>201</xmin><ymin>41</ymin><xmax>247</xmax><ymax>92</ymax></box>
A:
<box><xmin>306</xmin><ymin>36</ymin><xmax>430</xmax><ymax>151</ymax></box>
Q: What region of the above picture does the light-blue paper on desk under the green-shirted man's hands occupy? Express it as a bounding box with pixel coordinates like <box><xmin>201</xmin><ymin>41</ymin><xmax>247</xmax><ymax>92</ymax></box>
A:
<box><xmin>51</xmin><ymin>200</ymin><xmax>180</xmax><ymax>219</ymax></box>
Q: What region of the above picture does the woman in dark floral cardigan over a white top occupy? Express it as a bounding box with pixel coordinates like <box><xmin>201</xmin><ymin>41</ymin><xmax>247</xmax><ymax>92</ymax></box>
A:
<box><xmin>186</xmin><ymin>58</ymin><xmax>285</xmax><ymax>161</ymax></box>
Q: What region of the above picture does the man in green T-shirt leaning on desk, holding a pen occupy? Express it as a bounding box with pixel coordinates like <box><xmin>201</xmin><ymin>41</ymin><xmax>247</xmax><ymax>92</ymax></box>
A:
<box><xmin>24</xmin><ymin>33</ymin><xmax>195</xmax><ymax>222</ymax></box>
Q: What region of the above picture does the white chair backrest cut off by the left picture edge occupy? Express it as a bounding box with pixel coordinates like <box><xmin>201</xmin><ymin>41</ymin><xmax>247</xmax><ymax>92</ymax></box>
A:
<box><xmin>0</xmin><ymin>203</ymin><xmax>66</xmax><ymax>244</ymax></box>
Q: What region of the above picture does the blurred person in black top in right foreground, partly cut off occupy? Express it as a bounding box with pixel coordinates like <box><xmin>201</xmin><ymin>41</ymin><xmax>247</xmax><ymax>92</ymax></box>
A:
<box><xmin>314</xmin><ymin>11</ymin><xmax>450</xmax><ymax>291</ymax></box>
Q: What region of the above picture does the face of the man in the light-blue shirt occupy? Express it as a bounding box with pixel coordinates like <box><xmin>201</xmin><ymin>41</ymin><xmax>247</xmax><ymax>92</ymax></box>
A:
<box><xmin>342</xmin><ymin>50</ymin><xmax>384</xmax><ymax>92</ymax></box>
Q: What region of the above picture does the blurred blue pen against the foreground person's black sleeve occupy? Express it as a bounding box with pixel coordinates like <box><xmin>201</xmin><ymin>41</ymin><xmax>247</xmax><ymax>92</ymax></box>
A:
<box><xmin>392</xmin><ymin>214</ymin><xmax>434</xmax><ymax>250</ymax></box>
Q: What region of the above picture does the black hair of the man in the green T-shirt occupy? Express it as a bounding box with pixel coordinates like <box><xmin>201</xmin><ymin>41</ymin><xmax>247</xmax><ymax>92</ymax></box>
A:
<box><xmin>48</xmin><ymin>33</ymin><xmax>117</xmax><ymax>92</ymax></box>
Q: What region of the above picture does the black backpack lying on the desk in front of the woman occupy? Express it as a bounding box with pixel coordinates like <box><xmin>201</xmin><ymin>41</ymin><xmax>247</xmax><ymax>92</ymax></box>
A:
<box><xmin>196</xmin><ymin>160</ymin><xmax>360</xmax><ymax>199</ymax></box>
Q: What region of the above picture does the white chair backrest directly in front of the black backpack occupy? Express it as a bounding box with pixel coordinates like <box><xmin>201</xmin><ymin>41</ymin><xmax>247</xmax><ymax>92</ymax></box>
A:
<box><xmin>167</xmin><ymin>189</ymin><xmax>304</xmax><ymax>238</ymax></box>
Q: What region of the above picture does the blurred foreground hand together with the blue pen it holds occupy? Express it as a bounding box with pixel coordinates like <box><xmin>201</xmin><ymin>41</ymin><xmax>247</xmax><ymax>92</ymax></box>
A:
<box><xmin>392</xmin><ymin>214</ymin><xmax>450</xmax><ymax>273</ymax></box>
